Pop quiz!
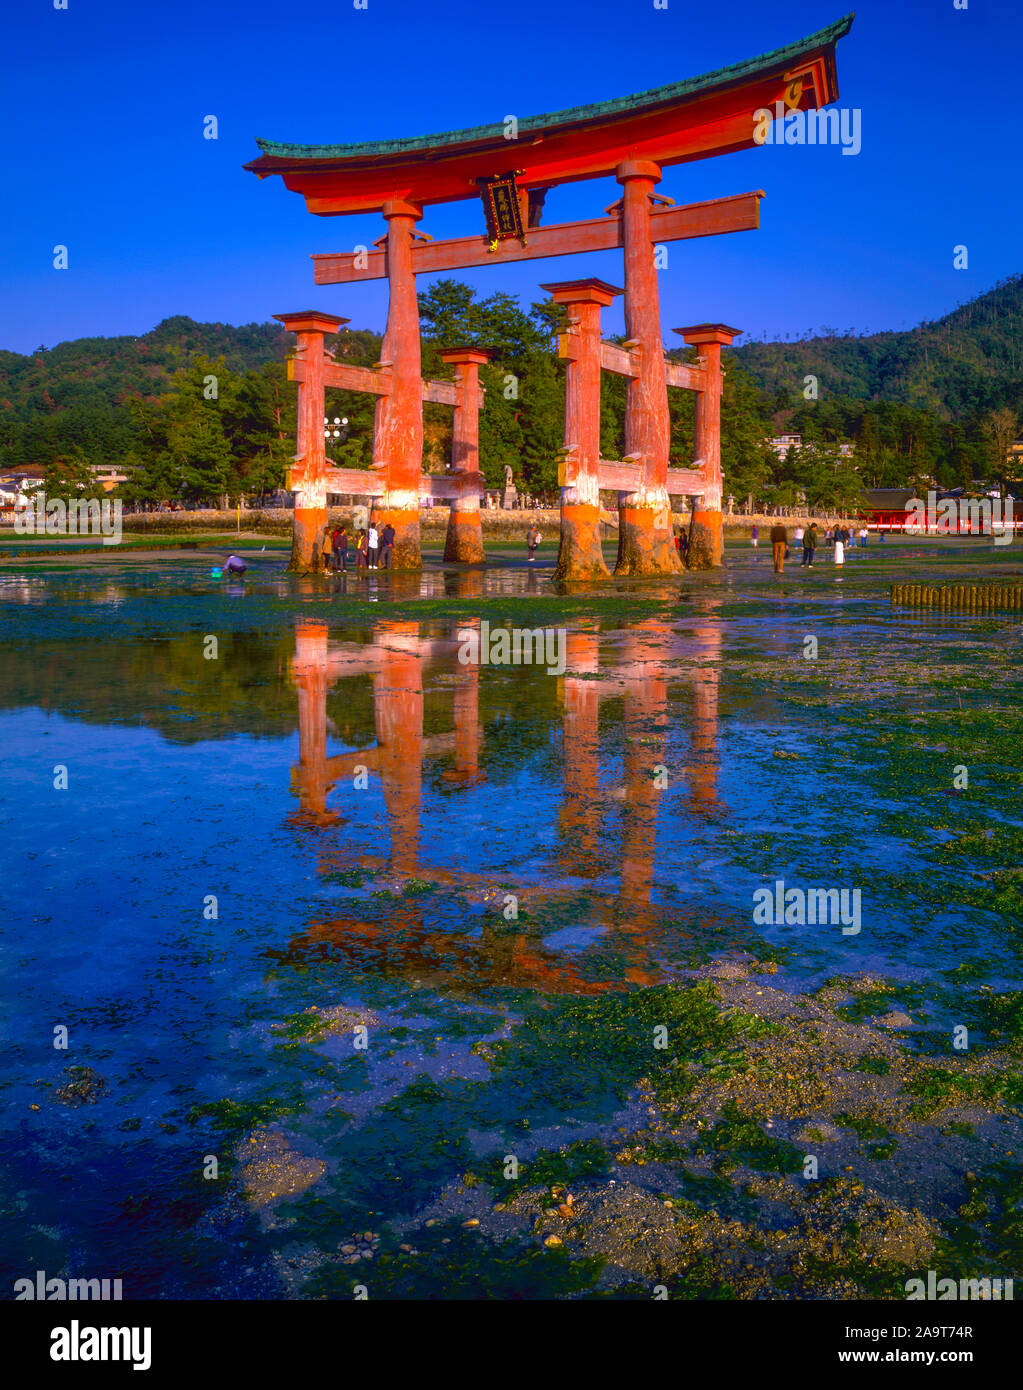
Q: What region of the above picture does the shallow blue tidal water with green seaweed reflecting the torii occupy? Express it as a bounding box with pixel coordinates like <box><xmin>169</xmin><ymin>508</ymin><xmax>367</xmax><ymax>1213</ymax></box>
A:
<box><xmin>0</xmin><ymin>542</ymin><xmax>1023</xmax><ymax>1298</ymax></box>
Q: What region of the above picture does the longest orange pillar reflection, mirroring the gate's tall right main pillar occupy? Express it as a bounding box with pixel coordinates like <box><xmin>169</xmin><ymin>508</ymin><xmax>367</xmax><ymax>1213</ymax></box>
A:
<box><xmin>621</xmin><ymin>623</ymin><xmax>669</xmax><ymax>910</ymax></box>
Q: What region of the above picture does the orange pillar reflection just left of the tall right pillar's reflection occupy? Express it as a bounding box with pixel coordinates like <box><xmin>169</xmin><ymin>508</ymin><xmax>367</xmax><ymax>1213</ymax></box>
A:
<box><xmin>559</xmin><ymin>632</ymin><xmax>602</xmax><ymax>873</ymax></box>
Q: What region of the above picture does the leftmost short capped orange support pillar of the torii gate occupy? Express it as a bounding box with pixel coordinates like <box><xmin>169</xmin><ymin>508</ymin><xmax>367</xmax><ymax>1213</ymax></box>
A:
<box><xmin>274</xmin><ymin>309</ymin><xmax>349</xmax><ymax>574</ymax></box>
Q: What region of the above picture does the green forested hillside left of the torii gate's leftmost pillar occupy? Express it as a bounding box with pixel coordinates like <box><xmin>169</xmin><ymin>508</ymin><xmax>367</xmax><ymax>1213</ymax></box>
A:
<box><xmin>0</xmin><ymin>317</ymin><xmax>379</xmax><ymax>502</ymax></box>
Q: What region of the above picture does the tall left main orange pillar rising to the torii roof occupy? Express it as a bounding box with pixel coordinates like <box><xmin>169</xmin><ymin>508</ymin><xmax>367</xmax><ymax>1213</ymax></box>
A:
<box><xmin>373</xmin><ymin>200</ymin><xmax>423</xmax><ymax>570</ymax></box>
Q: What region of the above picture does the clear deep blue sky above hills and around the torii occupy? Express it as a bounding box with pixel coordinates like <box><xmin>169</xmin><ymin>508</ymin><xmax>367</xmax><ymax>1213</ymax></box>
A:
<box><xmin>0</xmin><ymin>0</ymin><xmax>1023</xmax><ymax>352</ymax></box>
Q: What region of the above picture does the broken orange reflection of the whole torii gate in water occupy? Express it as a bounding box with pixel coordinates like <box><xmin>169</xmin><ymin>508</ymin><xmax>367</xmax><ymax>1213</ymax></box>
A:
<box><xmin>282</xmin><ymin>620</ymin><xmax>720</xmax><ymax>992</ymax></box>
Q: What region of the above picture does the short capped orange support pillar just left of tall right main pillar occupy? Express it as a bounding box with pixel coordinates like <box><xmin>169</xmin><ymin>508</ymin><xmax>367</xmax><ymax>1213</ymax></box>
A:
<box><xmin>541</xmin><ymin>279</ymin><xmax>621</xmax><ymax>580</ymax></box>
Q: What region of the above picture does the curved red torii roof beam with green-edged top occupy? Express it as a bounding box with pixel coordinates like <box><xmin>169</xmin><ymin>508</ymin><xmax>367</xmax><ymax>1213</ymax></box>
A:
<box><xmin>245</xmin><ymin>14</ymin><xmax>853</xmax><ymax>217</ymax></box>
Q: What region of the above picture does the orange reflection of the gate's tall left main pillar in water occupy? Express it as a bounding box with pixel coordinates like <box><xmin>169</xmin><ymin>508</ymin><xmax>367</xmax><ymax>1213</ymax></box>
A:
<box><xmin>373</xmin><ymin>623</ymin><xmax>423</xmax><ymax>874</ymax></box>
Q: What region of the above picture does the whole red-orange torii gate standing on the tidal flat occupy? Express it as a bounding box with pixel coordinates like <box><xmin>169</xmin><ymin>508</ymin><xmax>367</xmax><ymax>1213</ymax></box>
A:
<box><xmin>246</xmin><ymin>15</ymin><xmax>852</xmax><ymax>578</ymax></box>
